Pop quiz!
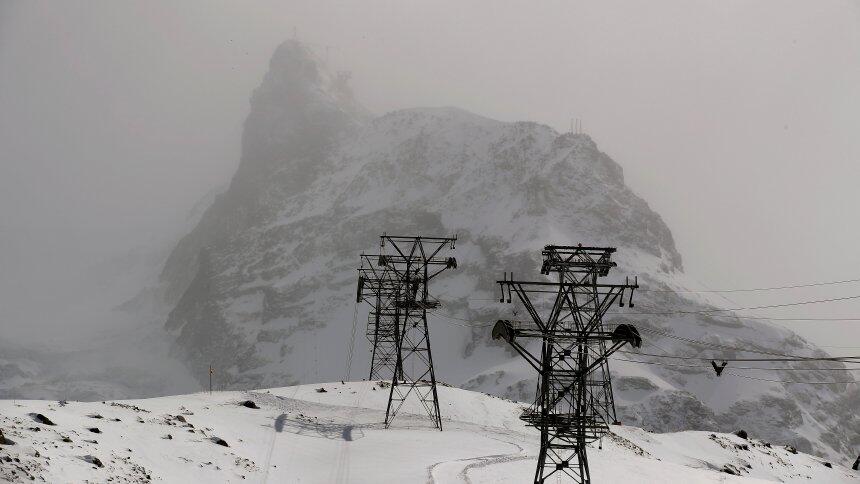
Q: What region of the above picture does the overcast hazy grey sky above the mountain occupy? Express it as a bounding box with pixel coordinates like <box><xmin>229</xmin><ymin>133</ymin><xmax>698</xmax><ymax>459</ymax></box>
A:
<box><xmin>0</xmin><ymin>0</ymin><xmax>860</xmax><ymax>346</ymax></box>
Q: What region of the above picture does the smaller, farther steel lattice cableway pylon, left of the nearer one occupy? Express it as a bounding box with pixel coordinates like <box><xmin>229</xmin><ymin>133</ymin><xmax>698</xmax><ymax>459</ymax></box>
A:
<box><xmin>356</xmin><ymin>234</ymin><xmax>457</xmax><ymax>430</ymax></box>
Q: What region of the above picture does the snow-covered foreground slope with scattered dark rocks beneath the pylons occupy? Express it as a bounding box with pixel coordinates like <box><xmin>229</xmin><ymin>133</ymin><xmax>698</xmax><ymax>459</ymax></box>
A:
<box><xmin>0</xmin><ymin>382</ymin><xmax>860</xmax><ymax>484</ymax></box>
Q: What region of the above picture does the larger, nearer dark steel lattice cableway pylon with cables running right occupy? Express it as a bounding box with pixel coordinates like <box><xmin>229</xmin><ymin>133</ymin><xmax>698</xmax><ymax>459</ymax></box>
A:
<box><xmin>492</xmin><ymin>245</ymin><xmax>642</xmax><ymax>484</ymax></box>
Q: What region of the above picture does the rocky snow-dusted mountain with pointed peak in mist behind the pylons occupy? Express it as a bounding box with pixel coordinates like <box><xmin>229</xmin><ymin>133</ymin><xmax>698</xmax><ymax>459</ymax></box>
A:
<box><xmin>156</xmin><ymin>41</ymin><xmax>860</xmax><ymax>456</ymax></box>
